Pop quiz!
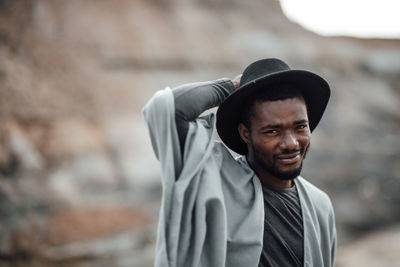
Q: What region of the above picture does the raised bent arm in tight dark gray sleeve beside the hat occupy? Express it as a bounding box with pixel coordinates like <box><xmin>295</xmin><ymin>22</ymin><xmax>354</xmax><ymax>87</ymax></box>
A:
<box><xmin>172</xmin><ymin>79</ymin><xmax>234</xmax><ymax>150</ymax></box>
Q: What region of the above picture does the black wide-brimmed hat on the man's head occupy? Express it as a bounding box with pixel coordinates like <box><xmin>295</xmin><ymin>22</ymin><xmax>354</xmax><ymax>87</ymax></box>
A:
<box><xmin>217</xmin><ymin>58</ymin><xmax>330</xmax><ymax>155</ymax></box>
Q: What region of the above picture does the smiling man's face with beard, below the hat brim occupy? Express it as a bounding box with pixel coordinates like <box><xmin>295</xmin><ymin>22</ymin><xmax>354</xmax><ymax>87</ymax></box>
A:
<box><xmin>239</xmin><ymin>97</ymin><xmax>311</xmax><ymax>183</ymax></box>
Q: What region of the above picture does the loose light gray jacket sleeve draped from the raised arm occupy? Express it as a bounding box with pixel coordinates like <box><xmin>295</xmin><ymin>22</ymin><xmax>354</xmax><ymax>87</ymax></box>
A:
<box><xmin>143</xmin><ymin>85</ymin><xmax>231</xmax><ymax>267</ymax></box>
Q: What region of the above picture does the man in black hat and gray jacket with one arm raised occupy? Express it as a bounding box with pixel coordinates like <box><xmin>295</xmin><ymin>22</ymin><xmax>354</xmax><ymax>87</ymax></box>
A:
<box><xmin>144</xmin><ymin>59</ymin><xmax>336</xmax><ymax>267</ymax></box>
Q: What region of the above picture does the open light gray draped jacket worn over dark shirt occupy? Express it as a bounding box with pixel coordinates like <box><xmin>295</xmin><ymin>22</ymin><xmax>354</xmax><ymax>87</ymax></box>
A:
<box><xmin>143</xmin><ymin>88</ymin><xmax>336</xmax><ymax>267</ymax></box>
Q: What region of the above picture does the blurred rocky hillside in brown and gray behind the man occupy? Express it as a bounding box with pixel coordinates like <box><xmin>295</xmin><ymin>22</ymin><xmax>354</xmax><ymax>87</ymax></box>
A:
<box><xmin>0</xmin><ymin>0</ymin><xmax>400</xmax><ymax>267</ymax></box>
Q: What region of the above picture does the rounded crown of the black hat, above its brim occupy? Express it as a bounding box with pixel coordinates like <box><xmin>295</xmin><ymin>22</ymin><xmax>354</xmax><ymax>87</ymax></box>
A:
<box><xmin>240</xmin><ymin>58</ymin><xmax>290</xmax><ymax>85</ymax></box>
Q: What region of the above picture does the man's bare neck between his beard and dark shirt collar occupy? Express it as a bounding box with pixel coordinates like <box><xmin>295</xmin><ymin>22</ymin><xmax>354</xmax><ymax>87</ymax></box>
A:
<box><xmin>246</xmin><ymin>155</ymin><xmax>293</xmax><ymax>188</ymax></box>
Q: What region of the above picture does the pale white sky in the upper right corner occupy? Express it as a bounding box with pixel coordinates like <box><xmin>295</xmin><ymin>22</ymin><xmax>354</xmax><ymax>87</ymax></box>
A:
<box><xmin>280</xmin><ymin>0</ymin><xmax>400</xmax><ymax>39</ymax></box>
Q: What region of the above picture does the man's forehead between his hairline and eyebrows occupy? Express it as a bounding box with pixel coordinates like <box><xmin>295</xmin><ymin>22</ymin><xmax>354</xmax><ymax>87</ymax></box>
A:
<box><xmin>251</xmin><ymin>97</ymin><xmax>308</xmax><ymax>124</ymax></box>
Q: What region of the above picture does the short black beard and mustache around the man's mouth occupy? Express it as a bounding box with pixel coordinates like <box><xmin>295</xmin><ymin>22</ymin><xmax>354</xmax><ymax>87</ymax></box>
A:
<box><xmin>253</xmin><ymin>145</ymin><xmax>310</xmax><ymax>181</ymax></box>
